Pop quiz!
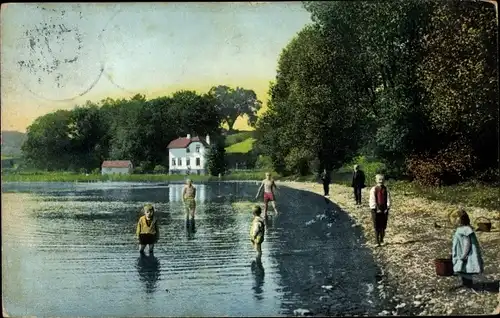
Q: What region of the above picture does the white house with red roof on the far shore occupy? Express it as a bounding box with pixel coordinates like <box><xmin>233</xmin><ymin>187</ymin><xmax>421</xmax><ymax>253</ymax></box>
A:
<box><xmin>167</xmin><ymin>134</ymin><xmax>210</xmax><ymax>174</ymax></box>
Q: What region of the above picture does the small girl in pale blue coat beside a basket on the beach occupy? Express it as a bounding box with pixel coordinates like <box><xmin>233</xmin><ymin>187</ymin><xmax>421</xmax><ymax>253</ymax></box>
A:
<box><xmin>452</xmin><ymin>210</ymin><xmax>484</xmax><ymax>287</ymax></box>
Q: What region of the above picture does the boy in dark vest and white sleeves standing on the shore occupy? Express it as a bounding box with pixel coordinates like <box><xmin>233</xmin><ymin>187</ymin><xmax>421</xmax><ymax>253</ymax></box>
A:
<box><xmin>370</xmin><ymin>174</ymin><xmax>391</xmax><ymax>246</ymax></box>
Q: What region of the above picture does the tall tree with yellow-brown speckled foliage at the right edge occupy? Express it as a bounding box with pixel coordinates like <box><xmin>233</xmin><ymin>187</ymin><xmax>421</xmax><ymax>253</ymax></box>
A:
<box><xmin>418</xmin><ymin>2</ymin><xmax>499</xmax><ymax>176</ymax></box>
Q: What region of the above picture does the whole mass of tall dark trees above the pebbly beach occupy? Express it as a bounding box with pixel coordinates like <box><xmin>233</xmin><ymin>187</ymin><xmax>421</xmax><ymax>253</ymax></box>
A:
<box><xmin>257</xmin><ymin>0</ymin><xmax>499</xmax><ymax>185</ymax></box>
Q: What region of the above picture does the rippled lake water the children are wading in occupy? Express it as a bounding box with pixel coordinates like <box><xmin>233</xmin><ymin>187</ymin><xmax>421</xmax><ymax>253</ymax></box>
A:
<box><xmin>2</xmin><ymin>182</ymin><xmax>379</xmax><ymax>317</ymax></box>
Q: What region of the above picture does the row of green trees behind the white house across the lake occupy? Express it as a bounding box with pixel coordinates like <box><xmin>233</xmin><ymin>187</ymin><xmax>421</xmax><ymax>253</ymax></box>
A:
<box><xmin>22</xmin><ymin>85</ymin><xmax>261</xmax><ymax>174</ymax></box>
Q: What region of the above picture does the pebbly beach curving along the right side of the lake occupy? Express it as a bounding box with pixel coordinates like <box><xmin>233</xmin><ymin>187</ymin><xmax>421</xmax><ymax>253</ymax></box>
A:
<box><xmin>278</xmin><ymin>181</ymin><xmax>500</xmax><ymax>315</ymax></box>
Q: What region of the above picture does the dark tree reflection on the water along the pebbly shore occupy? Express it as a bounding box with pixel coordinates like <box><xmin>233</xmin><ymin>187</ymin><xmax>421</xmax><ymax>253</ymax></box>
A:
<box><xmin>270</xmin><ymin>190</ymin><xmax>377</xmax><ymax>315</ymax></box>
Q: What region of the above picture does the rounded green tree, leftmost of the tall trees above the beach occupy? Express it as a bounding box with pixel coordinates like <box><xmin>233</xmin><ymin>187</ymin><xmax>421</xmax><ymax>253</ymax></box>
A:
<box><xmin>257</xmin><ymin>26</ymin><xmax>361</xmax><ymax>174</ymax></box>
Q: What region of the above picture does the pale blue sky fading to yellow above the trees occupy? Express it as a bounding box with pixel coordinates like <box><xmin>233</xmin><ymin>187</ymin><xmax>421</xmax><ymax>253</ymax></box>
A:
<box><xmin>1</xmin><ymin>2</ymin><xmax>310</xmax><ymax>131</ymax></box>
